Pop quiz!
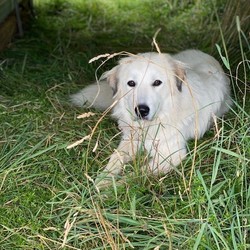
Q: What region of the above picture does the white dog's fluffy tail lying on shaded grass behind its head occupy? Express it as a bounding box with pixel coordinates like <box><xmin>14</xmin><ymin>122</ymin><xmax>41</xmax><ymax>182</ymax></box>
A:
<box><xmin>70</xmin><ymin>81</ymin><xmax>114</xmax><ymax>110</ymax></box>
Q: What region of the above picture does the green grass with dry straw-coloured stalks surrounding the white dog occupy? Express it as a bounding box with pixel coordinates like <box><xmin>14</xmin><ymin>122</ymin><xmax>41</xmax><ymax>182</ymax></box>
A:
<box><xmin>0</xmin><ymin>0</ymin><xmax>250</xmax><ymax>250</ymax></box>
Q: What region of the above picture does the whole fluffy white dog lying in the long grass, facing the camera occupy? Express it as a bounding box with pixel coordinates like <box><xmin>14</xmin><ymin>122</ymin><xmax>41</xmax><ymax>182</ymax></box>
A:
<box><xmin>72</xmin><ymin>50</ymin><xmax>231</xmax><ymax>185</ymax></box>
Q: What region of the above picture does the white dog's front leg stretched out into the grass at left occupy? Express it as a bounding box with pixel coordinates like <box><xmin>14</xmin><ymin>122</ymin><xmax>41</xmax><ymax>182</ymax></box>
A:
<box><xmin>95</xmin><ymin>140</ymin><xmax>137</xmax><ymax>187</ymax></box>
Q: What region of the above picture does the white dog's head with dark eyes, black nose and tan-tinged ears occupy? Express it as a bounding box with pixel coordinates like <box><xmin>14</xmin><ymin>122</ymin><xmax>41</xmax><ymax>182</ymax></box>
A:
<box><xmin>102</xmin><ymin>53</ymin><xmax>185</xmax><ymax>121</ymax></box>
